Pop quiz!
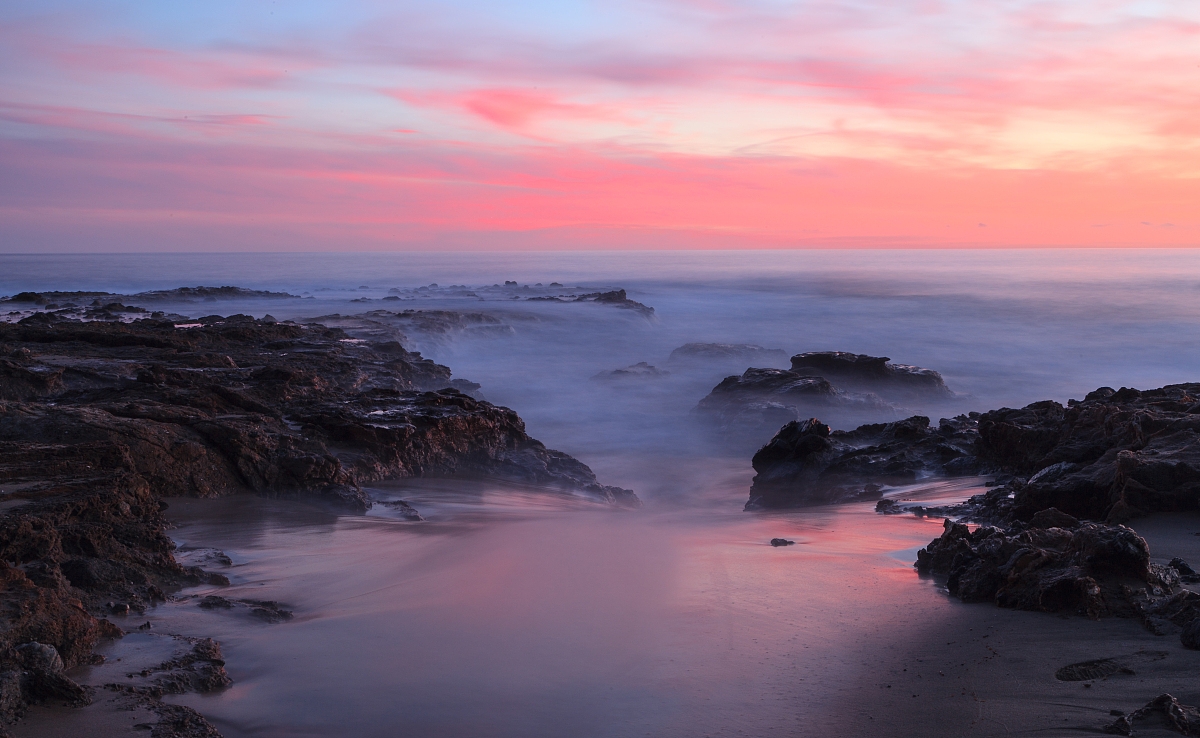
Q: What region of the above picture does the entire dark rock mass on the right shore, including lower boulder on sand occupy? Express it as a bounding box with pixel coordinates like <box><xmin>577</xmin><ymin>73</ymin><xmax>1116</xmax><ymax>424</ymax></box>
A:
<box><xmin>746</xmin><ymin>384</ymin><xmax>1200</xmax><ymax>648</ymax></box>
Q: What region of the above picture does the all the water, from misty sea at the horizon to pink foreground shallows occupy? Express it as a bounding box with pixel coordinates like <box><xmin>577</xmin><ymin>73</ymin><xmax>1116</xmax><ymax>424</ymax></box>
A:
<box><xmin>9</xmin><ymin>251</ymin><xmax>1200</xmax><ymax>738</ymax></box>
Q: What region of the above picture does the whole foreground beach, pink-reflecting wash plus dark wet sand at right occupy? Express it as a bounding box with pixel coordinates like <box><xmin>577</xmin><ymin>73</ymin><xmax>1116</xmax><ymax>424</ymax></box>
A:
<box><xmin>14</xmin><ymin>482</ymin><xmax>1200</xmax><ymax>738</ymax></box>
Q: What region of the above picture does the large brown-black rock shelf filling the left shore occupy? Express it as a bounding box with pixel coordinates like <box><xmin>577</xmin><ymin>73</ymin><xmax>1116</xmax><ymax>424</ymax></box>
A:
<box><xmin>0</xmin><ymin>313</ymin><xmax>637</xmax><ymax>729</ymax></box>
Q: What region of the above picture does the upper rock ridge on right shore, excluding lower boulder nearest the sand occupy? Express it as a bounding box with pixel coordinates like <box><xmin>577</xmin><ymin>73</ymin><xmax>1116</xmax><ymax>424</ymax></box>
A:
<box><xmin>752</xmin><ymin>384</ymin><xmax>1200</xmax><ymax>523</ymax></box>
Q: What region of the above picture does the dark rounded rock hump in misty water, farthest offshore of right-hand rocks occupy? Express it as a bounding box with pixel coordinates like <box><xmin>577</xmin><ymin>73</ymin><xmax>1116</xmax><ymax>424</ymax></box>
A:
<box><xmin>792</xmin><ymin>352</ymin><xmax>954</xmax><ymax>401</ymax></box>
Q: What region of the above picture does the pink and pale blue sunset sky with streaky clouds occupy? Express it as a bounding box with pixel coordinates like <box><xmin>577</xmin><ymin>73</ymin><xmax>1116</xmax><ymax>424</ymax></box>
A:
<box><xmin>0</xmin><ymin>0</ymin><xmax>1200</xmax><ymax>253</ymax></box>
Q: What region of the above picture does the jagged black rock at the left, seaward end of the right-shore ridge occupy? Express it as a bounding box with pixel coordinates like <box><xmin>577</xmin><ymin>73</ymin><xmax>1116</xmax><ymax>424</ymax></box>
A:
<box><xmin>746</xmin><ymin>415</ymin><xmax>977</xmax><ymax>510</ymax></box>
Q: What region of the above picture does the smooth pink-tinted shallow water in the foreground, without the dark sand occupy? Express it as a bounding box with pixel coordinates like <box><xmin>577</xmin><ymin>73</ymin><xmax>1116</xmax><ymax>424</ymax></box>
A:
<box><xmin>151</xmin><ymin>484</ymin><xmax>954</xmax><ymax>738</ymax></box>
